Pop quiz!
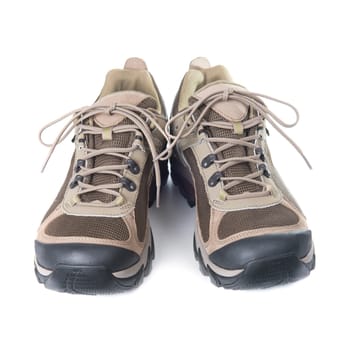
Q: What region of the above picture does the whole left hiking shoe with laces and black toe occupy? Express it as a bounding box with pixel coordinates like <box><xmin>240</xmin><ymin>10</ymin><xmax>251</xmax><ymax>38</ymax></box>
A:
<box><xmin>35</xmin><ymin>58</ymin><xmax>168</xmax><ymax>294</ymax></box>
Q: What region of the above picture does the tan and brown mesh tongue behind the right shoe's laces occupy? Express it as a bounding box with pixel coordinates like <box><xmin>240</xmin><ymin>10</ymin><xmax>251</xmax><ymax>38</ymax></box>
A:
<box><xmin>194</xmin><ymin>82</ymin><xmax>262</xmax><ymax>195</ymax></box>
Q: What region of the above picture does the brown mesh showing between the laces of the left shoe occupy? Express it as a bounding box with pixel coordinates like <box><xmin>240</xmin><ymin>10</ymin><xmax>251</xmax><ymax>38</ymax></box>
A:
<box><xmin>81</xmin><ymin>98</ymin><xmax>156</xmax><ymax>203</ymax></box>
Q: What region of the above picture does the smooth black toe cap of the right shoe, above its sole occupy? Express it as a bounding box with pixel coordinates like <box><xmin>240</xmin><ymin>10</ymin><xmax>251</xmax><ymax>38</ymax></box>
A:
<box><xmin>209</xmin><ymin>230</ymin><xmax>312</xmax><ymax>269</ymax></box>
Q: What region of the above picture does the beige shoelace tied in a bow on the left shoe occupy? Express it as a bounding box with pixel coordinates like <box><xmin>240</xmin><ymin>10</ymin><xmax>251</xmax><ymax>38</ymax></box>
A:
<box><xmin>39</xmin><ymin>104</ymin><xmax>168</xmax><ymax>207</ymax></box>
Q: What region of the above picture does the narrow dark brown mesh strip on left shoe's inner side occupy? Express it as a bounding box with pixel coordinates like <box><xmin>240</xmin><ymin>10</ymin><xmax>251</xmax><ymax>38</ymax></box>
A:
<box><xmin>135</xmin><ymin>158</ymin><xmax>152</xmax><ymax>242</ymax></box>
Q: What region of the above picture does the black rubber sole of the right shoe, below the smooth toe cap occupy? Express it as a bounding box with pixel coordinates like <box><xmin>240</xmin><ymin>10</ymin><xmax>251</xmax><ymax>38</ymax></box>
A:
<box><xmin>171</xmin><ymin>154</ymin><xmax>316</xmax><ymax>289</ymax></box>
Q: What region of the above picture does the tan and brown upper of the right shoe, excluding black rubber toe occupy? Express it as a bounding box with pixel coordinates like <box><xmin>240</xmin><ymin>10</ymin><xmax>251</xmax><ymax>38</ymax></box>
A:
<box><xmin>169</xmin><ymin>58</ymin><xmax>311</xmax><ymax>257</ymax></box>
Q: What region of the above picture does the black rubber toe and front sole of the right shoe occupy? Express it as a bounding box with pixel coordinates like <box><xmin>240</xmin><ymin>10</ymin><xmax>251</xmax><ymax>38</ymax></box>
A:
<box><xmin>194</xmin><ymin>231</ymin><xmax>316</xmax><ymax>289</ymax></box>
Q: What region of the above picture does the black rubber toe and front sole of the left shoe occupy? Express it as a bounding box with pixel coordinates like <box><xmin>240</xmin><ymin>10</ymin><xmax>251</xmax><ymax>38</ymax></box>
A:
<box><xmin>35</xmin><ymin>239</ymin><xmax>154</xmax><ymax>294</ymax></box>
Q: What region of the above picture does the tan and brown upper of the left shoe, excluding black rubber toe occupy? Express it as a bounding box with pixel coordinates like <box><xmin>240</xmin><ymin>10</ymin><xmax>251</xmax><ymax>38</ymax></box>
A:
<box><xmin>37</xmin><ymin>58</ymin><xmax>167</xmax><ymax>265</ymax></box>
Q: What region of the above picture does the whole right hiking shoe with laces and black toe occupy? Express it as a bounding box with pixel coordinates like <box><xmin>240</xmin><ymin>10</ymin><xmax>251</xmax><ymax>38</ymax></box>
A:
<box><xmin>167</xmin><ymin>58</ymin><xmax>315</xmax><ymax>289</ymax></box>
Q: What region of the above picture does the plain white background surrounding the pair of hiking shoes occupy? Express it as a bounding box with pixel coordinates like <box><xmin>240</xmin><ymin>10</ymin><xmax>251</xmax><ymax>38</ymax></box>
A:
<box><xmin>0</xmin><ymin>0</ymin><xmax>350</xmax><ymax>350</ymax></box>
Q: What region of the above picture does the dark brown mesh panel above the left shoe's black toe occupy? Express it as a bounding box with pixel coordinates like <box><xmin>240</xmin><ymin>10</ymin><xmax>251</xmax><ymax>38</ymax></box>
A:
<box><xmin>46</xmin><ymin>214</ymin><xmax>129</xmax><ymax>241</ymax></box>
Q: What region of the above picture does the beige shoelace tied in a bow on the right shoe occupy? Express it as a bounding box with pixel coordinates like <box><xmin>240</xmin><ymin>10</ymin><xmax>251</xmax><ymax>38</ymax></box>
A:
<box><xmin>161</xmin><ymin>88</ymin><xmax>311</xmax><ymax>199</ymax></box>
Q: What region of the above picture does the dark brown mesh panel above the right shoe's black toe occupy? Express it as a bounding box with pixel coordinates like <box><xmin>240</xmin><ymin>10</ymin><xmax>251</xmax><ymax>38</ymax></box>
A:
<box><xmin>218</xmin><ymin>204</ymin><xmax>299</xmax><ymax>239</ymax></box>
